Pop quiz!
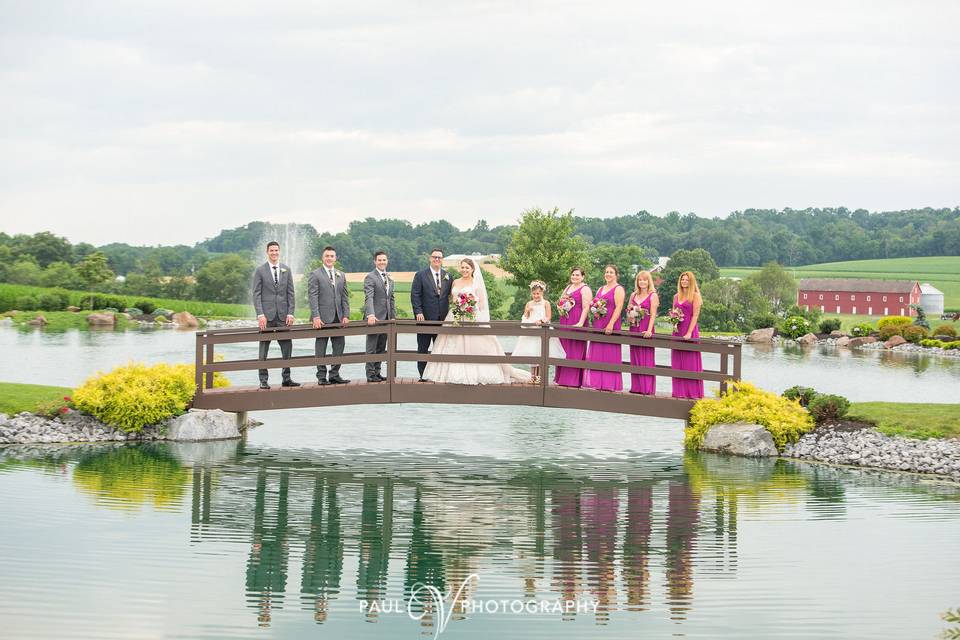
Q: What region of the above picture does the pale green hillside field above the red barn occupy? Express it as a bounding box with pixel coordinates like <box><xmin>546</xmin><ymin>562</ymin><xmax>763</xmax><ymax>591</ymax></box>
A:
<box><xmin>720</xmin><ymin>256</ymin><xmax>960</xmax><ymax>310</ymax></box>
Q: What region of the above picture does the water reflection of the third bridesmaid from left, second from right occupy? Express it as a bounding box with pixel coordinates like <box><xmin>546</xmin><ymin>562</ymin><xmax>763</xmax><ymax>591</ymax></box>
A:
<box><xmin>623</xmin><ymin>484</ymin><xmax>653</xmax><ymax>611</ymax></box>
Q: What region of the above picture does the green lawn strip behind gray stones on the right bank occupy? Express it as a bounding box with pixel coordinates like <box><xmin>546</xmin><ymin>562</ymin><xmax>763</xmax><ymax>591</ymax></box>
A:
<box><xmin>847</xmin><ymin>402</ymin><xmax>960</xmax><ymax>438</ymax></box>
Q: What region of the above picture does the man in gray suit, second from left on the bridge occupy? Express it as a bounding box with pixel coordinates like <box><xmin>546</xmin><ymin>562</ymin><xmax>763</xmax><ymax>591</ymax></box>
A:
<box><xmin>308</xmin><ymin>247</ymin><xmax>350</xmax><ymax>385</ymax></box>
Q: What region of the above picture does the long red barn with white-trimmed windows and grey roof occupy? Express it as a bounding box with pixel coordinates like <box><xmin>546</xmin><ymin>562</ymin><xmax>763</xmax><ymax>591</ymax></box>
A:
<box><xmin>797</xmin><ymin>278</ymin><xmax>920</xmax><ymax>316</ymax></box>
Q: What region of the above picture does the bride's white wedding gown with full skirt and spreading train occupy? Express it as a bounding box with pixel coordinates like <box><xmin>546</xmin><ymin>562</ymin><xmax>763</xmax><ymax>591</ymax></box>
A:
<box><xmin>423</xmin><ymin>285</ymin><xmax>530</xmax><ymax>384</ymax></box>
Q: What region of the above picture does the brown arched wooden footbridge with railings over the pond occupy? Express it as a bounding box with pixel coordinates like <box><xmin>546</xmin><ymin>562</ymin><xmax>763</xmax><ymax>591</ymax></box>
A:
<box><xmin>193</xmin><ymin>320</ymin><xmax>741</xmax><ymax>420</ymax></box>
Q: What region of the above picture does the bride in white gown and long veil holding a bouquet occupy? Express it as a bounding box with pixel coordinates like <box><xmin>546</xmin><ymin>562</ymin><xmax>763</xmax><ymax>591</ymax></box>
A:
<box><xmin>423</xmin><ymin>258</ymin><xmax>530</xmax><ymax>384</ymax></box>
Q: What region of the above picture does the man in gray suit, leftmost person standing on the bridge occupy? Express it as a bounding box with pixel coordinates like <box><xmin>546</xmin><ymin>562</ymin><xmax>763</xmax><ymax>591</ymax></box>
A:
<box><xmin>253</xmin><ymin>241</ymin><xmax>300</xmax><ymax>389</ymax></box>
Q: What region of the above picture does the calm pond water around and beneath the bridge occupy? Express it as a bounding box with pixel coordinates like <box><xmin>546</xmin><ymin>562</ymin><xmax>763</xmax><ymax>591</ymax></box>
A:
<box><xmin>0</xmin><ymin>331</ymin><xmax>960</xmax><ymax>639</ymax></box>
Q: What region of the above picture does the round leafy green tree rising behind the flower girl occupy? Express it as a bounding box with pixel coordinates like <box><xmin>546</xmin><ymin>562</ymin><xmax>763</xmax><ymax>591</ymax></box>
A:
<box><xmin>501</xmin><ymin>208</ymin><xmax>589</xmax><ymax>318</ymax></box>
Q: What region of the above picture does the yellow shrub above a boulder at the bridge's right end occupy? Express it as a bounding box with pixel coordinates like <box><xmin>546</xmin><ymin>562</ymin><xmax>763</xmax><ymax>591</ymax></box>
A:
<box><xmin>684</xmin><ymin>382</ymin><xmax>814</xmax><ymax>451</ymax></box>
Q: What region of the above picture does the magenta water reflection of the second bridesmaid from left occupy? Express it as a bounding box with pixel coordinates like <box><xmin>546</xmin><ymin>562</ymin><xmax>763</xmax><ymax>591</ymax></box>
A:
<box><xmin>580</xmin><ymin>486</ymin><xmax>618</xmax><ymax>624</ymax></box>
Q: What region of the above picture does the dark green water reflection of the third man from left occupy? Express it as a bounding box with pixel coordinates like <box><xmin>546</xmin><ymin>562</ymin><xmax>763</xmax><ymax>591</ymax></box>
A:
<box><xmin>357</xmin><ymin>481</ymin><xmax>393</xmax><ymax>619</ymax></box>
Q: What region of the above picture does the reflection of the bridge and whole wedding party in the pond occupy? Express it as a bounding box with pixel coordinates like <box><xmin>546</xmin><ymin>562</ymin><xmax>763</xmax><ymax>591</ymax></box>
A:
<box><xmin>180</xmin><ymin>448</ymin><xmax>806</xmax><ymax>626</ymax></box>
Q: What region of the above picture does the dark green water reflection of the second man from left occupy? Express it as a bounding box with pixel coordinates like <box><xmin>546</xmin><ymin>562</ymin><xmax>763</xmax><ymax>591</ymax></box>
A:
<box><xmin>300</xmin><ymin>475</ymin><xmax>343</xmax><ymax>623</ymax></box>
